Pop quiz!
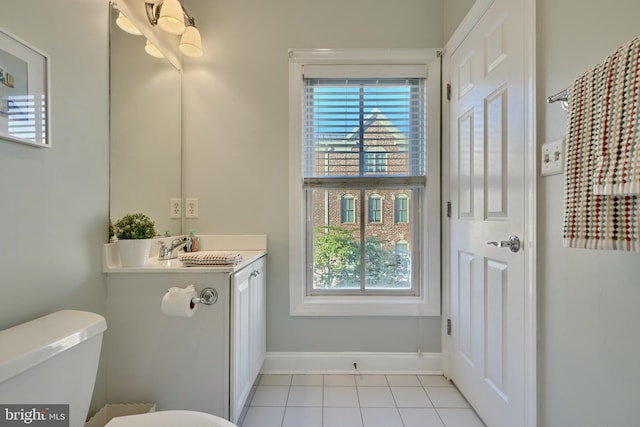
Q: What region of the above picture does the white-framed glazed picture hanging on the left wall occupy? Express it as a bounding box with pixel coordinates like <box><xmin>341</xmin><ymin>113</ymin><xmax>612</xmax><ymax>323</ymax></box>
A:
<box><xmin>0</xmin><ymin>28</ymin><xmax>51</xmax><ymax>148</ymax></box>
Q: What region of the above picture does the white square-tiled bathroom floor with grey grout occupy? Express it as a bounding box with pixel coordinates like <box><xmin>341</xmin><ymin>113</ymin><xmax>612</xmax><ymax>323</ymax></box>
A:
<box><xmin>241</xmin><ymin>375</ymin><xmax>484</xmax><ymax>427</ymax></box>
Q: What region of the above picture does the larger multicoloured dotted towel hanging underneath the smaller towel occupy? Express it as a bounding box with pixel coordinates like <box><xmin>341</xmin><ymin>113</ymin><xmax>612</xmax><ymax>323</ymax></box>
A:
<box><xmin>563</xmin><ymin>49</ymin><xmax>640</xmax><ymax>251</ymax></box>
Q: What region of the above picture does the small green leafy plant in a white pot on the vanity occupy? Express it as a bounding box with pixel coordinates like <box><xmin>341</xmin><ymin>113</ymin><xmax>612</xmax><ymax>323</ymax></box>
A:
<box><xmin>113</xmin><ymin>213</ymin><xmax>157</xmax><ymax>267</ymax></box>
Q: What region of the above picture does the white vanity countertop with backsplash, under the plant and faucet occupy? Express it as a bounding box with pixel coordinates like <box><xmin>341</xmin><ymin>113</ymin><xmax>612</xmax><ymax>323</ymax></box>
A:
<box><xmin>102</xmin><ymin>235</ymin><xmax>267</xmax><ymax>273</ymax></box>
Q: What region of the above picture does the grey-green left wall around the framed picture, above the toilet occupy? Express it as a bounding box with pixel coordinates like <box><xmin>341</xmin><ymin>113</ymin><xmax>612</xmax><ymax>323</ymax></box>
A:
<box><xmin>0</xmin><ymin>0</ymin><xmax>109</xmax><ymax>414</ymax></box>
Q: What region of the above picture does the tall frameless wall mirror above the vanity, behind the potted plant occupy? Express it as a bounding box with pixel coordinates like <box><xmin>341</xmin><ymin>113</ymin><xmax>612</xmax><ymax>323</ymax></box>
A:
<box><xmin>109</xmin><ymin>4</ymin><xmax>182</xmax><ymax>235</ymax></box>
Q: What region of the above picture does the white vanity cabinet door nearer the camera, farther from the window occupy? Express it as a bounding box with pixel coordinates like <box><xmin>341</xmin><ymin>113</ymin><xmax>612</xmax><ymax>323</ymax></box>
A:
<box><xmin>230</xmin><ymin>267</ymin><xmax>253</xmax><ymax>423</ymax></box>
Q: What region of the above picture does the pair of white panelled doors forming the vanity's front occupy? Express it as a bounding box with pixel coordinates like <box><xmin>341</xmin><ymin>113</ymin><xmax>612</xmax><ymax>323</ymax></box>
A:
<box><xmin>230</xmin><ymin>258</ymin><xmax>266</xmax><ymax>422</ymax></box>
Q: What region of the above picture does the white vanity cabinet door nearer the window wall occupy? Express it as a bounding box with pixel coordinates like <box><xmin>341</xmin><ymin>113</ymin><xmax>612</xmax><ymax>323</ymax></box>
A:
<box><xmin>250</xmin><ymin>258</ymin><xmax>267</xmax><ymax>383</ymax></box>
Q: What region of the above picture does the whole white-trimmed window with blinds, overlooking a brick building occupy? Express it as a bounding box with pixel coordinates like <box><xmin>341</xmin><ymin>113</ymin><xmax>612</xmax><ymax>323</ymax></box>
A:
<box><xmin>290</xmin><ymin>49</ymin><xmax>440</xmax><ymax>315</ymax></box>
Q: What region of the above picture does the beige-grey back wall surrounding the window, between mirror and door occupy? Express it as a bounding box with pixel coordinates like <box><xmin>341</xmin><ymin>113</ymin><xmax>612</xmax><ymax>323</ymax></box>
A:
<box><xmin>184</xmin><ymin>0</ymin><xmax>443</xmax><ymax>352</ymax></box>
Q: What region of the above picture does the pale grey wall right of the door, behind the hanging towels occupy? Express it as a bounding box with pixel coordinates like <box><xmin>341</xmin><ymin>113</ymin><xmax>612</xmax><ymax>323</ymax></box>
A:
<box><xmin>537</xmin><ymin>0</ymin><xmax>640</xmax><ymax>427</ymax></box>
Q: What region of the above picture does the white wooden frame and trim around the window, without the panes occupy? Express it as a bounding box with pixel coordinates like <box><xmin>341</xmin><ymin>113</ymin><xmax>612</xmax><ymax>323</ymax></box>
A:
<box><xmin>289</xmin><ymin>49</ymin><xmax>441</xmax><ymax>316</ymax></box>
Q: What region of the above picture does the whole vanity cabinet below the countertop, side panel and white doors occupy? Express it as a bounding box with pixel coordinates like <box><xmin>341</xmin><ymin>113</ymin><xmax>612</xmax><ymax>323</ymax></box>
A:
<box><xmin>101</xmin><ymin>241</ymin><xmax>266</xmax><ymax>423</ymax></box>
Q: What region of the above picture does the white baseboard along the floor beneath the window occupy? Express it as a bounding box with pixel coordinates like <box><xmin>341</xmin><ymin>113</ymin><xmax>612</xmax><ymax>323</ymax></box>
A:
<box><xmin>262</xmin><ymin>352</ymin><xmax>442</xmax><ymax>375</ymax></box>
